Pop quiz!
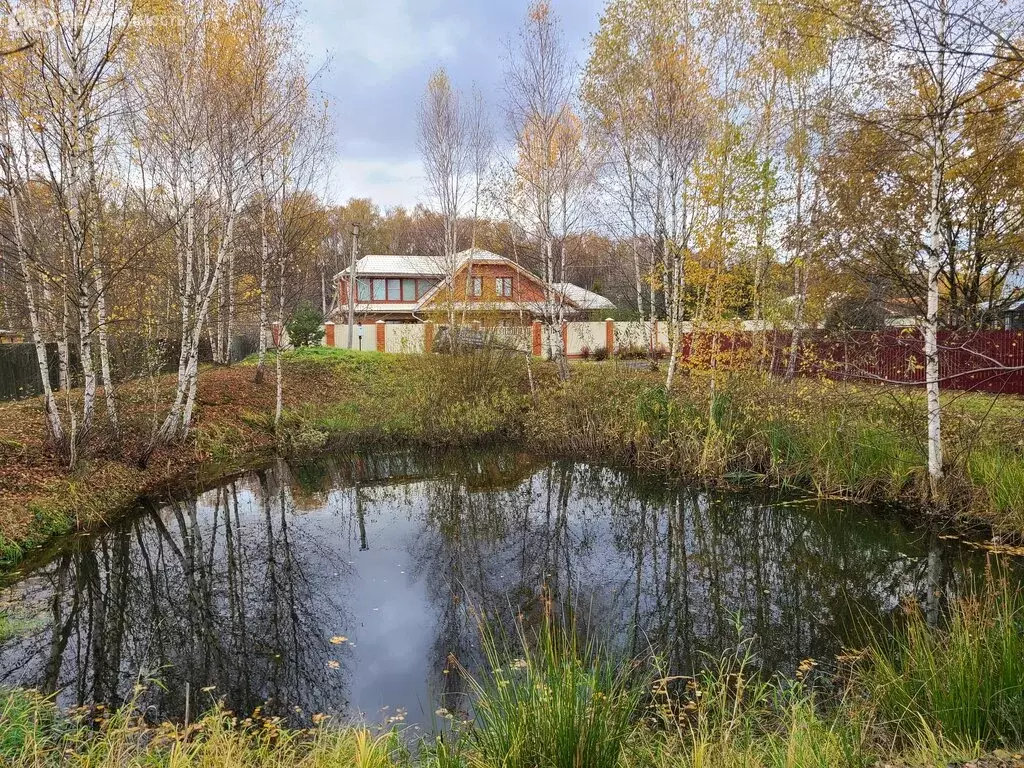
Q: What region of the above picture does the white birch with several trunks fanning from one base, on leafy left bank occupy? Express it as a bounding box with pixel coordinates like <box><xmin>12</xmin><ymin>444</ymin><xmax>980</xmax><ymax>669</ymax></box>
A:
<box><xmin>137</xmin><ymin>2</ymin><xmax>258</xmax><ymax>440</ymax></box>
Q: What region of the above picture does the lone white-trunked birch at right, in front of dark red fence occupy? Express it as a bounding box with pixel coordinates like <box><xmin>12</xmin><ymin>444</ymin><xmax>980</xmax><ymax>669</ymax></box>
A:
<box><xmin>835</xmin><ymin>0</ymin><xmax>1020</xmax><ymax>503</ymax></box>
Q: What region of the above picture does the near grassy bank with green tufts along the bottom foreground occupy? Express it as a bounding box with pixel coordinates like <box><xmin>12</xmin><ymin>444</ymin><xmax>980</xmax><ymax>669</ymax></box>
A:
<box><xmin>0</xmin><ymin>581</ymin><xmax>1024</xmax><ymax>768</ymax></box>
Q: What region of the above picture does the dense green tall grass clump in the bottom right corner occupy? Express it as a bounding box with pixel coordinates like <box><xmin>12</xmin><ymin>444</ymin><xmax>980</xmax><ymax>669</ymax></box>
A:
<box><xmin>860</xmin><ymin>575</ymin><xmax>1024</xmax><ymax>746</ymax></box>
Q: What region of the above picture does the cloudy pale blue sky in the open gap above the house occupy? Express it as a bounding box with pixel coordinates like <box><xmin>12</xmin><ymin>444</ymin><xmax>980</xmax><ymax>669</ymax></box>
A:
<box><xmin>301</xmin><ymin>0</ymin><xmax>603</xmax><ymax>208</ymax></box>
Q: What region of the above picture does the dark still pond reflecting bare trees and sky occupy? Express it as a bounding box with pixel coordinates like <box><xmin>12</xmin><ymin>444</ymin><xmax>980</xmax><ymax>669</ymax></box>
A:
<box><xmin>0</xmin><ymin>452</ymin><xmax>999</xmax><ymax>728</ymax></box>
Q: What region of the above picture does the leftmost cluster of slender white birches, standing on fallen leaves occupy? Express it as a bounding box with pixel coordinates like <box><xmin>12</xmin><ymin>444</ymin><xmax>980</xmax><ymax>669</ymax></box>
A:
<box><xmin>0</xmin><ymin>0</ymin><xmax>134</xmax><ymax>465</ymax></box>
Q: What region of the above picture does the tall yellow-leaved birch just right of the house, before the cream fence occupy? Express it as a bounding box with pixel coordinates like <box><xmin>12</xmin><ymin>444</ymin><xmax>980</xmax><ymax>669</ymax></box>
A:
<box><xmin>584</xmin><ymin>0</ymin><xmax>712</xmax><ymax>387</ymax></box>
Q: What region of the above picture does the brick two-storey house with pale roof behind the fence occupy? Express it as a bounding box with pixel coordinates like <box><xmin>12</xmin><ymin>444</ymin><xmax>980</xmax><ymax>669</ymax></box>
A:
<box><xmin>332</xmin><ymin>249</ymin><xmax>614</xmax><ymax>325</ymax></box>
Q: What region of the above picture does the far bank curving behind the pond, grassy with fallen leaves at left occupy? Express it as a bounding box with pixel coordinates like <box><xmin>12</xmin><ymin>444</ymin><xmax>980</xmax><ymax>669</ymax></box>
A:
<box><xmin>0</xmin><ymin>349</ymin><xmax>1024</xmax><ymax>562</ymax></box>
